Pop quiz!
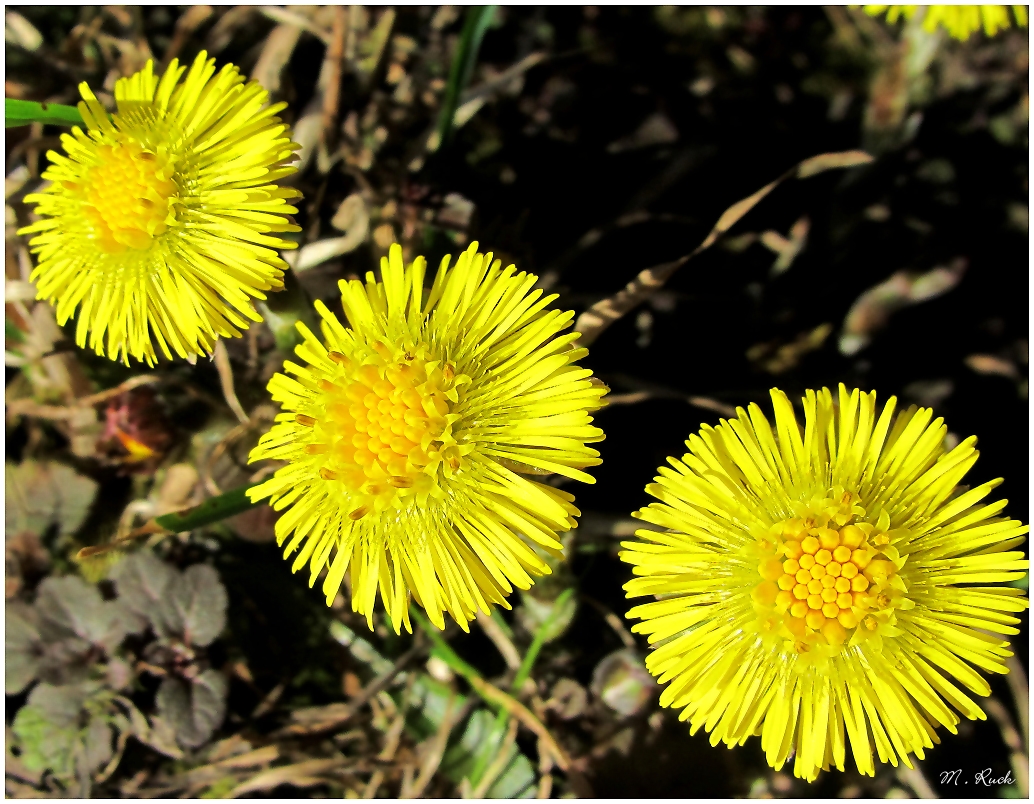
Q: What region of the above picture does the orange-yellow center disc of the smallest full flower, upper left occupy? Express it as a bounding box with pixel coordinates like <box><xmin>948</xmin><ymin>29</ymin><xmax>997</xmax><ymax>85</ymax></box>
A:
<box><xmin>74</xmin><ymin>142</ymin><xmax>177</xmax><ymax>254</ymax></box>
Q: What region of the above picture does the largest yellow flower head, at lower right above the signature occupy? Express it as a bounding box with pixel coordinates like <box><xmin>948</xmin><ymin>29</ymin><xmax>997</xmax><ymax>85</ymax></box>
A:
<box><xmin>620</xmin><ymin>385</ymin><xmax>1028</xmax><ymax>780</ymax></box>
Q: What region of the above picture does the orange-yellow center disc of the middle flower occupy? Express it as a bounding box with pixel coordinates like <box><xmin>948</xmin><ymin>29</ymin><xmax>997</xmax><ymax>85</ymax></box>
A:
<box><xmin>299</xmin><ymin>343</ymin><xmax>467</xmax><ymax>520</ymax></box>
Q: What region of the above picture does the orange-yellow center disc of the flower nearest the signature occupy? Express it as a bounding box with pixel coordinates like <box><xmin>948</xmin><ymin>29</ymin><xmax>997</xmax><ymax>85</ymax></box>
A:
<box><xmin>752</xmin><ymin>487</ymin><xmax>905</xmax><ymax>653</ymax></box>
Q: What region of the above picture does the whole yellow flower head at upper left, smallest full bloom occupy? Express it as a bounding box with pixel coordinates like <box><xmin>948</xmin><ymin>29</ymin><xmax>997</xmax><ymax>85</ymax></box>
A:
<box><xmin>20</xmin><ymin>52</ymin><xmax>300</xmax><ymax>365</ymax></box>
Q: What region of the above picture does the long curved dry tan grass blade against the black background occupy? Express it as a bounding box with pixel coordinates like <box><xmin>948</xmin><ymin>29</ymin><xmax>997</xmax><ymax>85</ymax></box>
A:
<box><xmin>575</xmin><ymin>151</ymin><xmax>873</xmax><ymax>346</ymax></box>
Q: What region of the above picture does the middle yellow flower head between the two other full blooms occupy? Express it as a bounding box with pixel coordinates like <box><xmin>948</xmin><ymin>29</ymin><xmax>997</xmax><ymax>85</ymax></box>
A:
<box><xmin>249</xmin><ymin>243</ymin><xmax>606</xmax><ymax>631</ymax></box>
